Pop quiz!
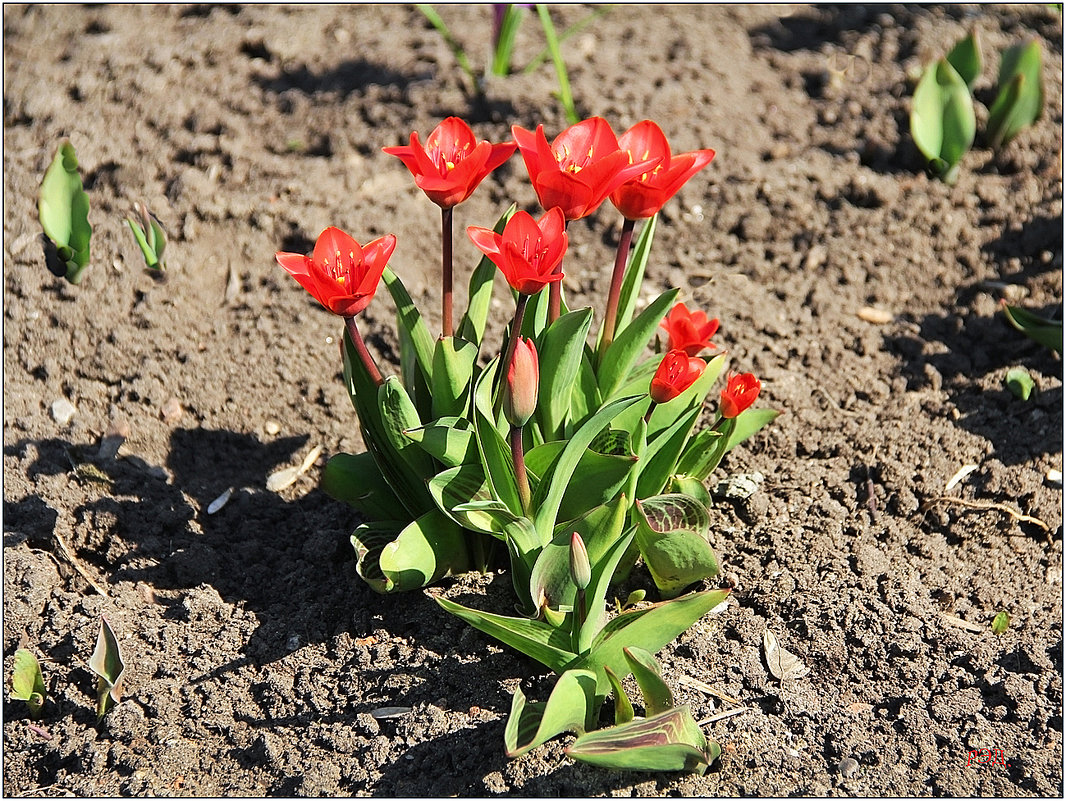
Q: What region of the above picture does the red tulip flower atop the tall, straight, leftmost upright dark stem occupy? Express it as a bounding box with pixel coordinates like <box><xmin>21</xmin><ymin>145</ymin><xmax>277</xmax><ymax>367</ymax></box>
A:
<box><xmin>383</xmin><ymin>117</ymin><xmax>516</xmax><ymax>209</ymax></box>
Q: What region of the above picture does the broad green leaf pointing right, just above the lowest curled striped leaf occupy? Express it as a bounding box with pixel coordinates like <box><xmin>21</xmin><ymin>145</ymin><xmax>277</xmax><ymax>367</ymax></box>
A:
<box><xmin>575</xmin><ymin>590</ymin><xmax>729</xmax><ymax>694</ymax></box>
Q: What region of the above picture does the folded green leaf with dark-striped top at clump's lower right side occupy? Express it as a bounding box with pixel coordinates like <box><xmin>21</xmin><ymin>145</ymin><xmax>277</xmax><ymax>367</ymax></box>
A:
<box><xmin>636</xmin><ymin>495</ymin><xmax>718</xmax><ymax>598</ymax></box>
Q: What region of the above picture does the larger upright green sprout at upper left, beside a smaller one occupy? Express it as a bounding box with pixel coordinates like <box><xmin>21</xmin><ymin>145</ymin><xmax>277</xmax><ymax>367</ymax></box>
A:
<box><xmin>37</xmin><ymin>141</ymin><xmax>93</xmax><ymax>284</ymax></box>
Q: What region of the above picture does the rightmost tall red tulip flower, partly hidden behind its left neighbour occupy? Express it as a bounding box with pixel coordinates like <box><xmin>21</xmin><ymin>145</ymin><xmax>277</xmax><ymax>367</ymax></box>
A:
<box><xmin>611</xmin><ymin>119</ymin><xmax>714</xmax><ymax>220</ymax></box>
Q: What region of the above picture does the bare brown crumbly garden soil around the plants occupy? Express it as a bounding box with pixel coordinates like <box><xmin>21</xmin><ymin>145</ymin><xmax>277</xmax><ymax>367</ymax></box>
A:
<box><xmin>3</xmin><ymin>4</ymin><xmax>1063</xmax><ymax>796</ymax></box>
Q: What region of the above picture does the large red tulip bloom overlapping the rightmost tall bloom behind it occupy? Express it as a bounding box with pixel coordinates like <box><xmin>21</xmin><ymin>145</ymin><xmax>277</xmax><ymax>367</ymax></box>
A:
<box><xmin>511</xmin><ymin>117</ymin><xmax>659</xmax><ymax>220</ymax></box>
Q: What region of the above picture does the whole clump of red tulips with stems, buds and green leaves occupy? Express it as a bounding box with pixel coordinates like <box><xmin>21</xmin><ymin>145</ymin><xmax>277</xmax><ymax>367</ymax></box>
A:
<box><xmin>277</xmin><ymin>117</ymin><xmax>777</xmax><ymax>772</ymax></box>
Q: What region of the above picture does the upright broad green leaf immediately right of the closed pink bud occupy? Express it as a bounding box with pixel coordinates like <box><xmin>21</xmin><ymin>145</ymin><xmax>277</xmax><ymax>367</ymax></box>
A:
<box><xmin>537</xmin><ymin>308</ymin><xmax>593</xmax><ymax>440</ymax></box>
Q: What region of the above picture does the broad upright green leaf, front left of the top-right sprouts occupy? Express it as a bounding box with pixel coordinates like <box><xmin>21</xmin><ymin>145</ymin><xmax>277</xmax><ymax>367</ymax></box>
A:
<box><xmin>910</xmin><ymin>59</ymin><xmax>978</xmax><ymax>183</ymax></box>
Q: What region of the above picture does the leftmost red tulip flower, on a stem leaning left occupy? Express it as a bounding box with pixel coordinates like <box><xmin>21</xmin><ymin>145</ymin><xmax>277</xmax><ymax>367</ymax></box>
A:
<box><xmin>274</xmin><ymin>227</ymin><xmax>397</xmax><ymax>318</ymax></box>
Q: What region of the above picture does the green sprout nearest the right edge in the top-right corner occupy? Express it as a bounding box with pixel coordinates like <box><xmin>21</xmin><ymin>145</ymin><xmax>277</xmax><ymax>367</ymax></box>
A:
<box><xmin>985</xmin><ymin>41</ymin><xmax>1044</xmax><ymax>150</ymax></box>
